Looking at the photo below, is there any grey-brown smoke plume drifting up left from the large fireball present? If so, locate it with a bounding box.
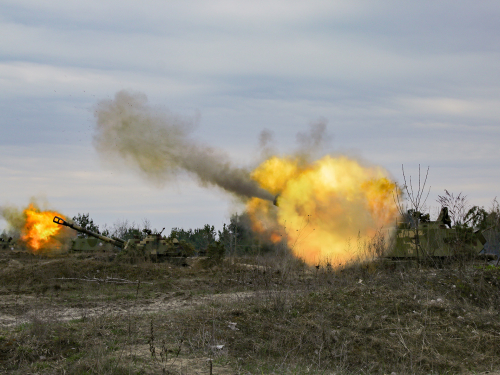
[94,91,274,201]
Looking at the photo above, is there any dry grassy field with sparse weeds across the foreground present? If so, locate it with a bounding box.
[0,252,500,374]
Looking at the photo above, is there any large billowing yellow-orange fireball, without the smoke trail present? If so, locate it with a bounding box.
[247,156,398,266]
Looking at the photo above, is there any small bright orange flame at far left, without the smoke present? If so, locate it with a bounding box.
[21,203,64,251]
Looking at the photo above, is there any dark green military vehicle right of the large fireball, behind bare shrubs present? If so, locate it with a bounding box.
[386,207,486,259]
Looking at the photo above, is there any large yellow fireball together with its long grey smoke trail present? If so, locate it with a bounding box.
[94,91,397,265]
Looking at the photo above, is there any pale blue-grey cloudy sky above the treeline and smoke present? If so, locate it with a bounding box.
[0,0,500,231]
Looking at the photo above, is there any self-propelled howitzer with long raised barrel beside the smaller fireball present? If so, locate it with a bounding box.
[53,216,193,264]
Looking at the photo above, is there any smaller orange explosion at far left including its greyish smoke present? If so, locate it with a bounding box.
[1,203,69,253]
